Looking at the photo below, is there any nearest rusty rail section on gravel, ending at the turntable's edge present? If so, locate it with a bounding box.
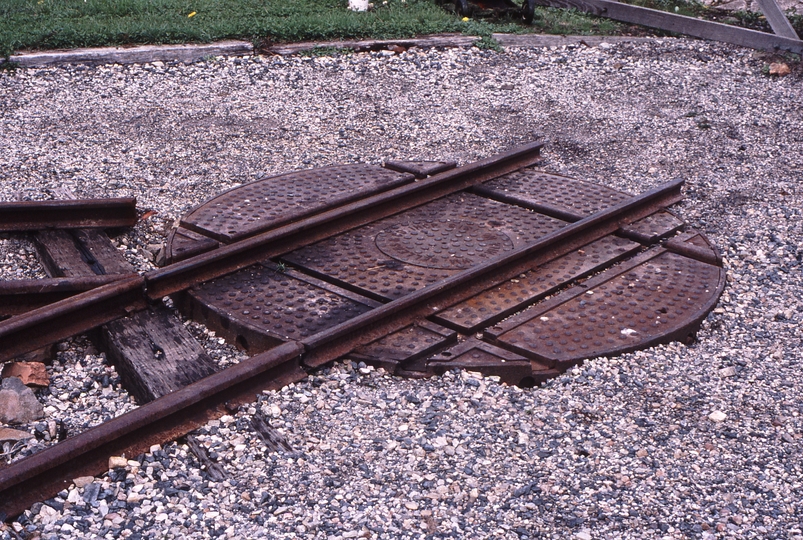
[0,342,306,516]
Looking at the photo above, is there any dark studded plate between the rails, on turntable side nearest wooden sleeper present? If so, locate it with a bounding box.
[182,265,376,352]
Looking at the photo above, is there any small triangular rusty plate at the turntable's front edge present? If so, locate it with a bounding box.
[426,338,560,387]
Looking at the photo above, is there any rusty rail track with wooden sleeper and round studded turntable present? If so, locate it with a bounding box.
[0,143,725,517]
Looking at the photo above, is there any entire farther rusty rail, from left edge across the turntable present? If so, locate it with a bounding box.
[0,141,544,361]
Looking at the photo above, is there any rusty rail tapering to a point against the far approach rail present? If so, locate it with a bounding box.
[0,274,136,317]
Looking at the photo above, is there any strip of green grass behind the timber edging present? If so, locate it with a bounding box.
[0,0,623,56]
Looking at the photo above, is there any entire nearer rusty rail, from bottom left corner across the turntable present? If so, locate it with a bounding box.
[0,177,682,515]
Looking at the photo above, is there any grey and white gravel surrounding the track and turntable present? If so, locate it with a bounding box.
[0,39,803,539]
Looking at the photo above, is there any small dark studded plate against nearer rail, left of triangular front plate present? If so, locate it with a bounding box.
[349,321,457,373]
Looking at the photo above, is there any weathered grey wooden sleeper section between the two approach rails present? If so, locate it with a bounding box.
[102,306,217,403]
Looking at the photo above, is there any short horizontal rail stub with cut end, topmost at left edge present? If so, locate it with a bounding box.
[0,197,137,232]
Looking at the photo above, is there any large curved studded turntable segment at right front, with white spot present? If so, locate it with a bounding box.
[486,248,725,368]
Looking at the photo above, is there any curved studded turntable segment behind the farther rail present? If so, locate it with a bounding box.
[181,164,414,243]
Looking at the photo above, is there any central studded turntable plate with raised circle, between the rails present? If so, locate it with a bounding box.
[283,193,566,300]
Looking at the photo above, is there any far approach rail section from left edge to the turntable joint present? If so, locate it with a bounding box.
[0,276,147,361]
